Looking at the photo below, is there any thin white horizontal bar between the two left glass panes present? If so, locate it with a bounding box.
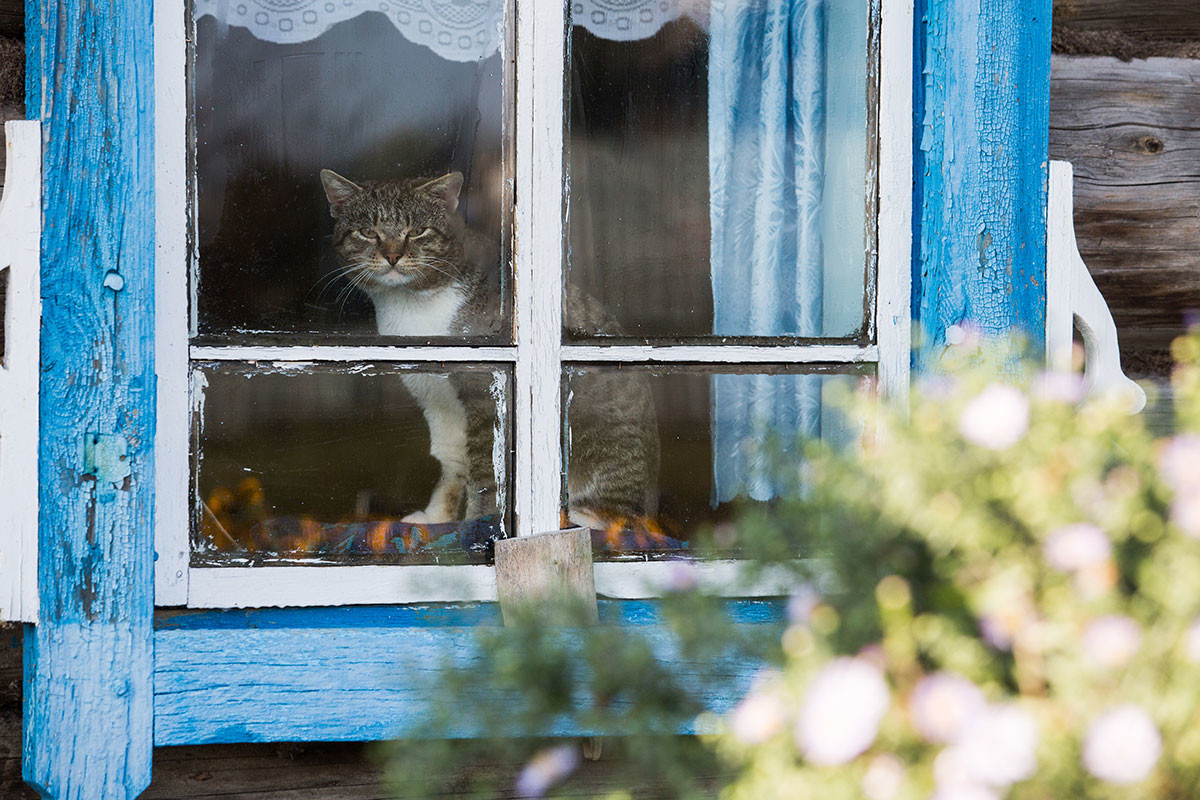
[191,345,517,363]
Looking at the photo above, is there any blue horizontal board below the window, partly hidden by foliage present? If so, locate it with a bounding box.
[155,601,784,745]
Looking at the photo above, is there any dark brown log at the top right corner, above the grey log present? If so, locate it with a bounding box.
[1054,0,1200,40]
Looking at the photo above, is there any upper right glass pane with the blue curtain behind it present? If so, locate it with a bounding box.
[564,0,875,339]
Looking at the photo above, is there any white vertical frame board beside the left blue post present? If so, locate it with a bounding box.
[154,0,191,606]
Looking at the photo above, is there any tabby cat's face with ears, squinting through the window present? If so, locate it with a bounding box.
[320,169,466,293]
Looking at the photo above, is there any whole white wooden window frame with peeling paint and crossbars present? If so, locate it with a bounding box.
[154,0,913,608]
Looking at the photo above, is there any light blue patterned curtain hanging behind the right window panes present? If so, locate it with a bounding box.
[708,0,827,503]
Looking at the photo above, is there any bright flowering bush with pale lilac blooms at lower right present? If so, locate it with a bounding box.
[709,328,1200,800]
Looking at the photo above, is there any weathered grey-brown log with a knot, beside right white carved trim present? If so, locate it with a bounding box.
[1050,55,1200,371]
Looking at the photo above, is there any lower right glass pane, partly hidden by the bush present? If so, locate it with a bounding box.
[564,366,864,554]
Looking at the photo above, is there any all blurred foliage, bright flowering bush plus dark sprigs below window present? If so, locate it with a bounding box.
[381,331,1200,800]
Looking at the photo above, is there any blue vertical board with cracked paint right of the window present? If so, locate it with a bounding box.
[913,0,1051,367]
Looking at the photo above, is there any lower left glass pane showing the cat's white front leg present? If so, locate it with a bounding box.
[192,363,511,564]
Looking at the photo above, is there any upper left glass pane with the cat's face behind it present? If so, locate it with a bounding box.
[191,6,511,342]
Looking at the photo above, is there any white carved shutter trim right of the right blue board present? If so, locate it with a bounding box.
[1046,161,1146,414]
